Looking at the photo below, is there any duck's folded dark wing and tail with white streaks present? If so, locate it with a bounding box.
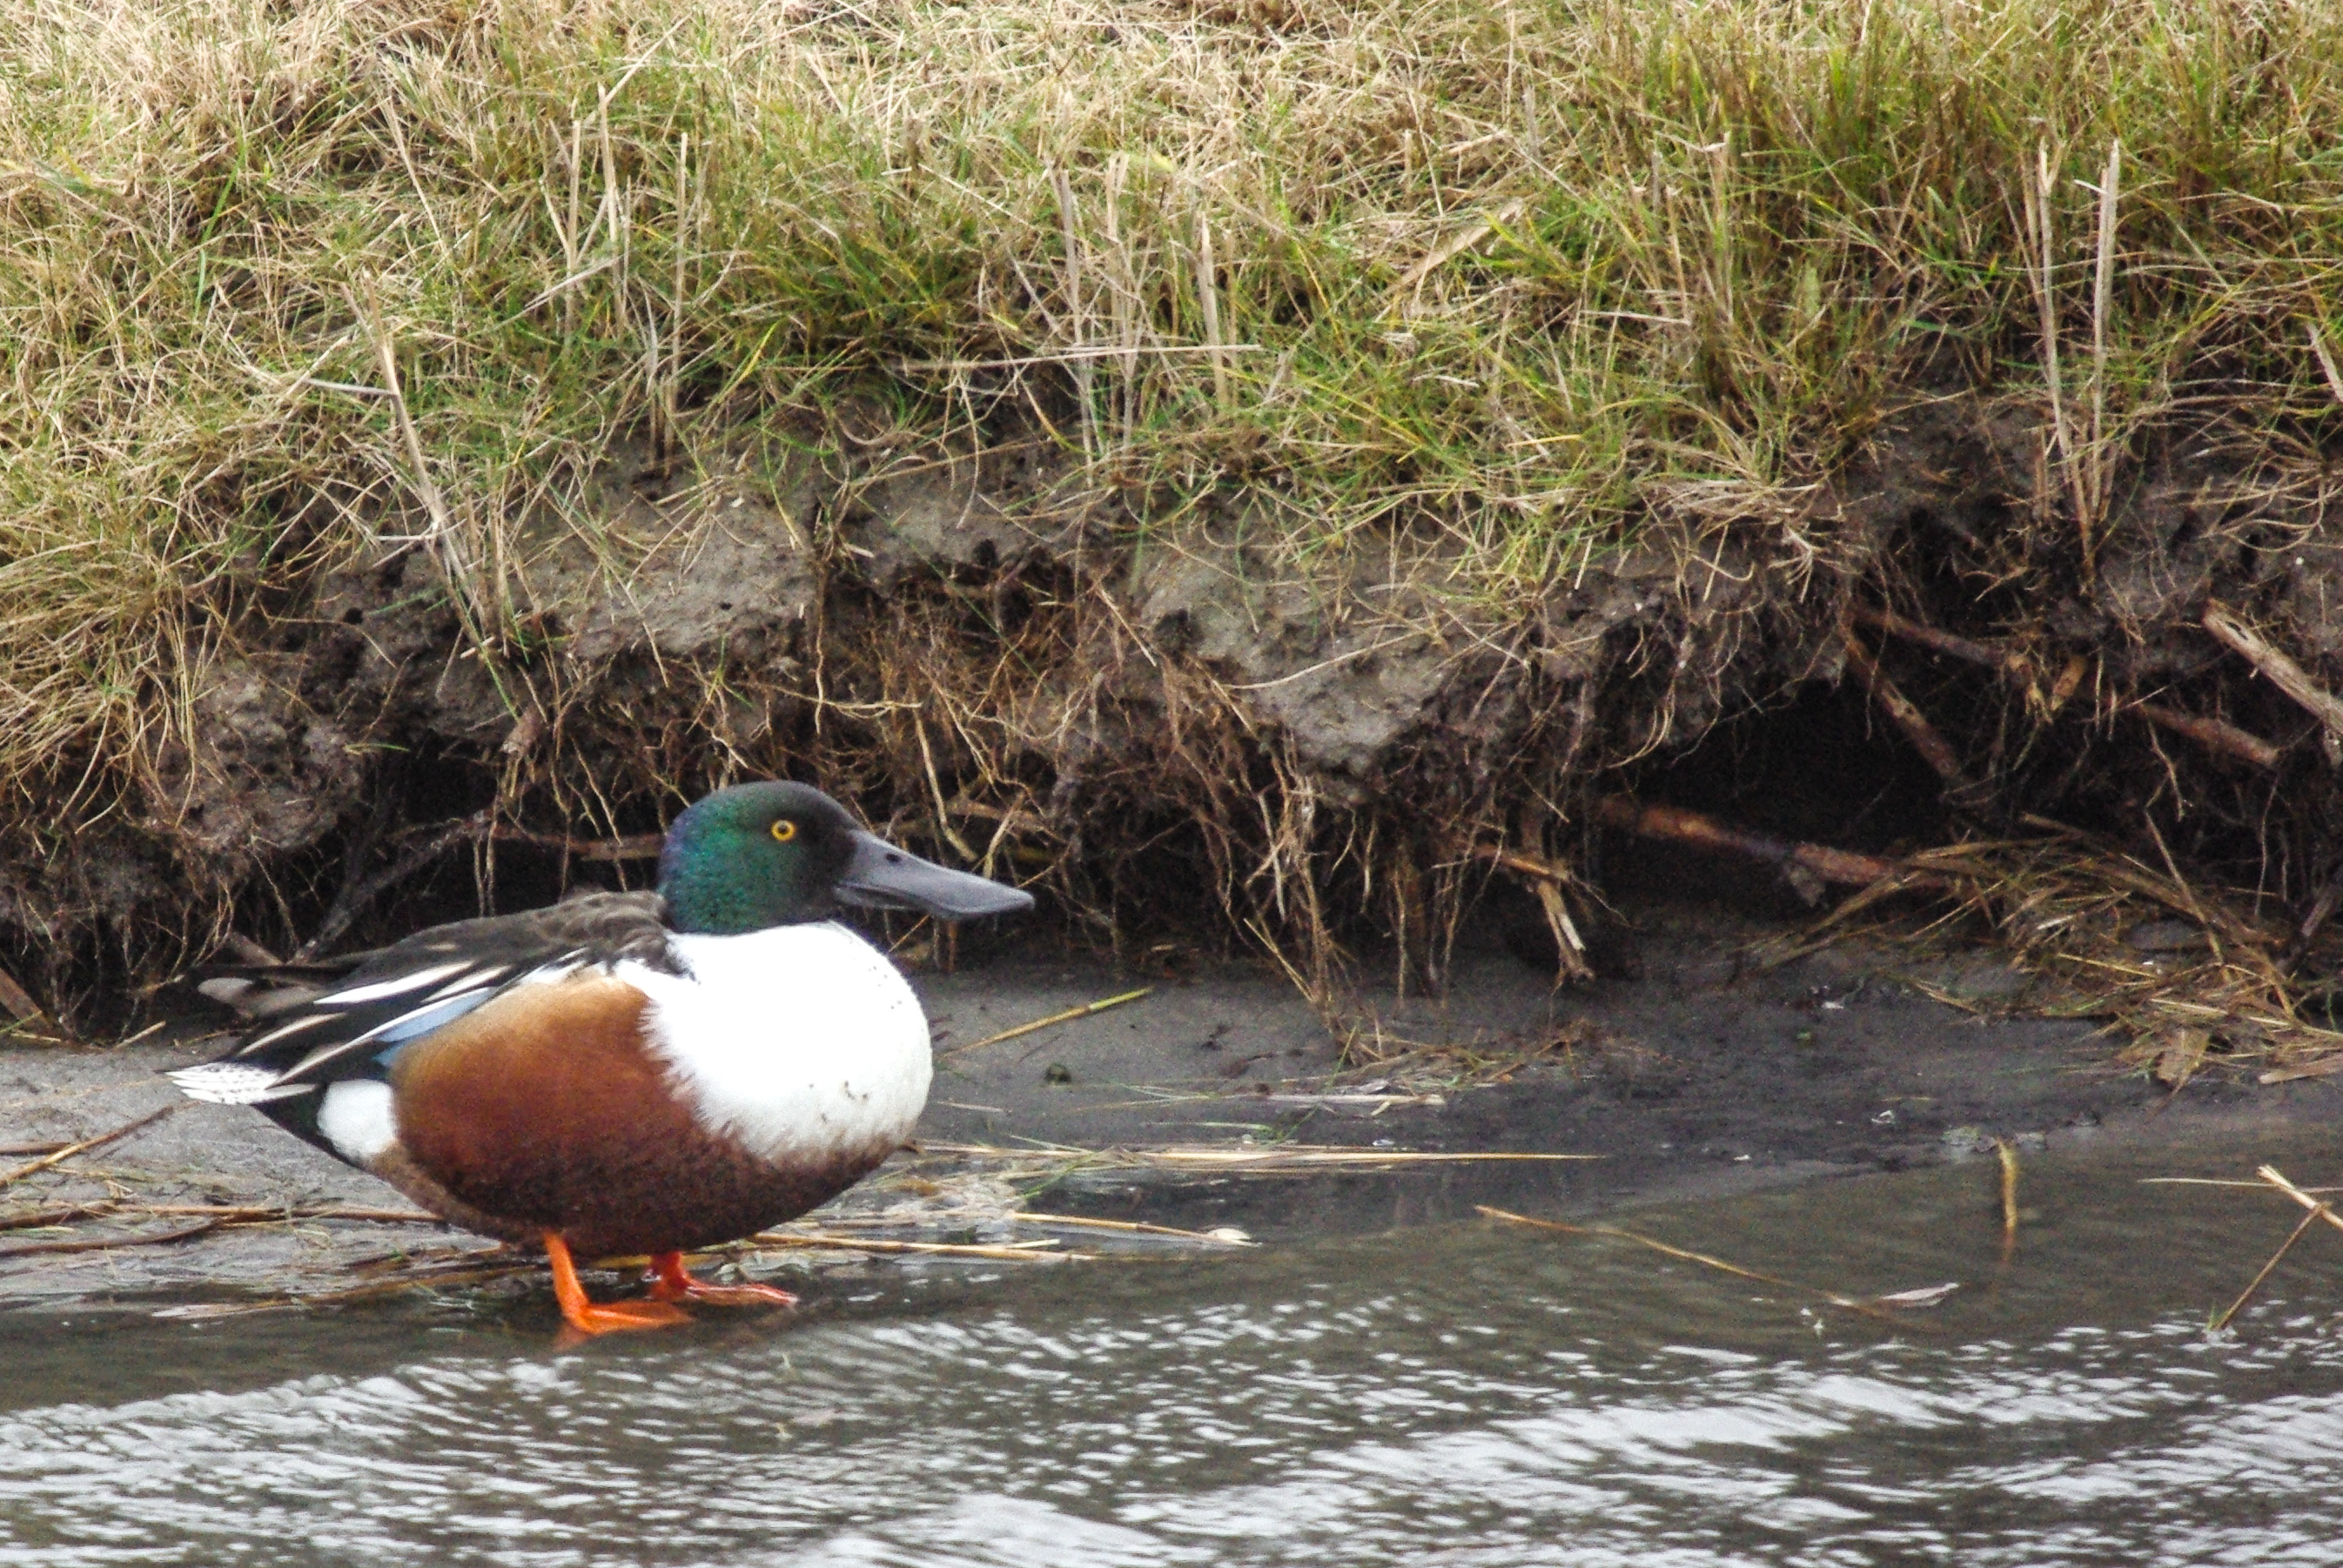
[169,893,668,1104]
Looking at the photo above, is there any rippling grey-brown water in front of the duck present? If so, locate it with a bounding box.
[0,1151,2343,1568]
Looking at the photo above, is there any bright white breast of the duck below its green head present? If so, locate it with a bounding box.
[616,921,935,1163]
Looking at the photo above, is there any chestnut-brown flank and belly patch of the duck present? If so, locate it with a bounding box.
[375,973,893,1256]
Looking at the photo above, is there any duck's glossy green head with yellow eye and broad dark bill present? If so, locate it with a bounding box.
[658,781,1033,935]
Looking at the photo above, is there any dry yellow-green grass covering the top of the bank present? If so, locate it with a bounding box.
[0,0,2343,979]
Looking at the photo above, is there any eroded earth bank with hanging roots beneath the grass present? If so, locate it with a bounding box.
[0,382,2343,1101]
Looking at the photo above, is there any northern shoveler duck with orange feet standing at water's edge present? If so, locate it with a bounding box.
[171,783,1033,1334]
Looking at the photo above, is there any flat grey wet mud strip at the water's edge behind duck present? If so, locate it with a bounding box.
[0,905,2336,1312]
